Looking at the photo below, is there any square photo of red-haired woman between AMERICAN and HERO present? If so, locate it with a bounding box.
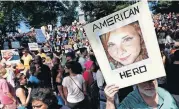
[100,21,148,69]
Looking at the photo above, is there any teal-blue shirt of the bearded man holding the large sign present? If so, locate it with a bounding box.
[117,87,179,109]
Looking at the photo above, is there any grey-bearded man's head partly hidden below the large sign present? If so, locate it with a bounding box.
[137,79,158,97]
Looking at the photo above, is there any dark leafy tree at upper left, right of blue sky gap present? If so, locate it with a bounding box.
[18,1,65,28]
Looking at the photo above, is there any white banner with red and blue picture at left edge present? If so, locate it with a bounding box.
[1,49,20,65]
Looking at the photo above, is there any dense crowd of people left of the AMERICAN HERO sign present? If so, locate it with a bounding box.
[0,23,105,109]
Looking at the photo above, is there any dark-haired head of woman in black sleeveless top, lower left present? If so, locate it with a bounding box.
[15,73,27,86]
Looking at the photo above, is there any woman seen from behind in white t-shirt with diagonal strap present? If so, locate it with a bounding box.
[62,61,87,109]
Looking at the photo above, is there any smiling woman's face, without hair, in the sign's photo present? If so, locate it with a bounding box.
[107,25,141,65]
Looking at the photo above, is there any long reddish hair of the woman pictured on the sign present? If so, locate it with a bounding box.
[101,21,148,68]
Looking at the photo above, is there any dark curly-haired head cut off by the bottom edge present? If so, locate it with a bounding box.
[31,88,59,109]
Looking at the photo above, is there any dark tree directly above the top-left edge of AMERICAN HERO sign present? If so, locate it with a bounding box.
[81,1,135,22]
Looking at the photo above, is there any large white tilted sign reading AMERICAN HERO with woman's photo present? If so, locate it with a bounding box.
[84,1,166,88]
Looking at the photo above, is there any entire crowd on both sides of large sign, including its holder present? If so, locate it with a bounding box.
[0,13,179,109]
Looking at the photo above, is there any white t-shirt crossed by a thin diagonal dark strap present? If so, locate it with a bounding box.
[62,74,85,103]
